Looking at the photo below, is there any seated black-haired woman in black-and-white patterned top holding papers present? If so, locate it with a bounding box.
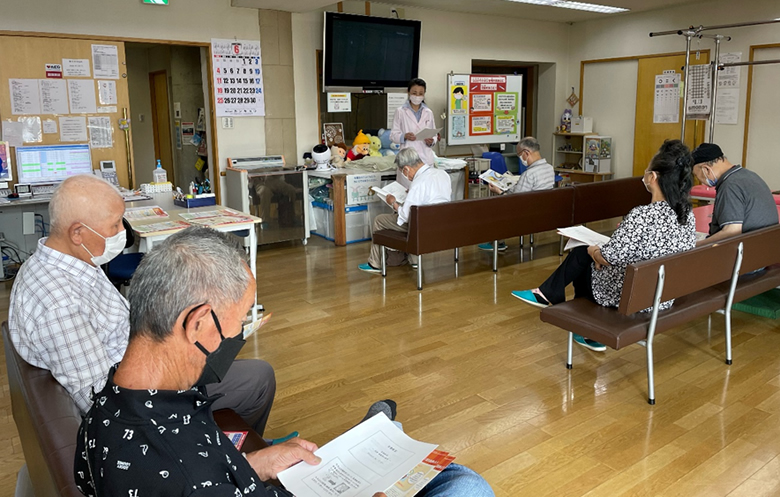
[512,140,696,350]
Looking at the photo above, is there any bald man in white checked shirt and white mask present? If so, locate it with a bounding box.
[8,175,276,434]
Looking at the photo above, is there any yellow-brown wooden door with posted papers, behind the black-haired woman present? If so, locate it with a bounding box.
[634,51,709,176]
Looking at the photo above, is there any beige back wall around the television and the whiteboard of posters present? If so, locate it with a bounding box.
[293,1,571,161]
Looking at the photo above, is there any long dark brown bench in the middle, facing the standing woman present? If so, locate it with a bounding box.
[373,178,650,290]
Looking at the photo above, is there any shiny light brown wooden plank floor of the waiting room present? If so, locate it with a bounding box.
[0,233,780,497]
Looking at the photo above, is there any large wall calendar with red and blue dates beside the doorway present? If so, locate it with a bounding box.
[211,39,265,117]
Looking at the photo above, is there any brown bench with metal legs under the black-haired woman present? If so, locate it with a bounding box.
[540,225,780,404]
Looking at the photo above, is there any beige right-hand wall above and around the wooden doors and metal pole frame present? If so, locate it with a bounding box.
[569,0,780,184]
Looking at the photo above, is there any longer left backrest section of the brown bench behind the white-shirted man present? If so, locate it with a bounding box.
[407,188,574,254]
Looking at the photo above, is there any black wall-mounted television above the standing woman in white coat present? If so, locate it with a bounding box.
[323,12,421,88]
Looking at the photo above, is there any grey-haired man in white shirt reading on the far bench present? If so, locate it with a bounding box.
[358,148,452,273]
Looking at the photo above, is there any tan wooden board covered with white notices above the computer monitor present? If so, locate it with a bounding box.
[0,35,132,188]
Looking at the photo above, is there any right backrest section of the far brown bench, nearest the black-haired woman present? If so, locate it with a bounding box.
[572,178,650,225]
